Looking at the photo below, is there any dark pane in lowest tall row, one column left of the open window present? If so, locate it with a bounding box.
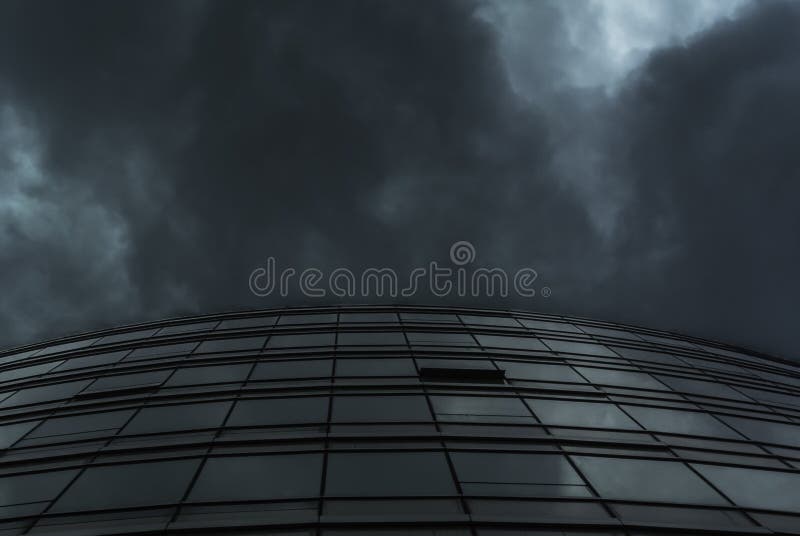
[325,451,456,497]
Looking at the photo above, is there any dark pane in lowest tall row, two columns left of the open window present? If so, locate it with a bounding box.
[189,453,322,501]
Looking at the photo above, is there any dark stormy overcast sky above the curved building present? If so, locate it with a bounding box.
[0,0,800,357]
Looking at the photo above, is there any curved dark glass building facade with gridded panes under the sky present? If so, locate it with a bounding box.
[0,306,800,536]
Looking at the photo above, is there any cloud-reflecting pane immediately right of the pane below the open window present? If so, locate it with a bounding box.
[526,398,640,430]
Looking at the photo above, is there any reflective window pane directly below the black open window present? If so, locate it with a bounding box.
[431,395,535,424]
